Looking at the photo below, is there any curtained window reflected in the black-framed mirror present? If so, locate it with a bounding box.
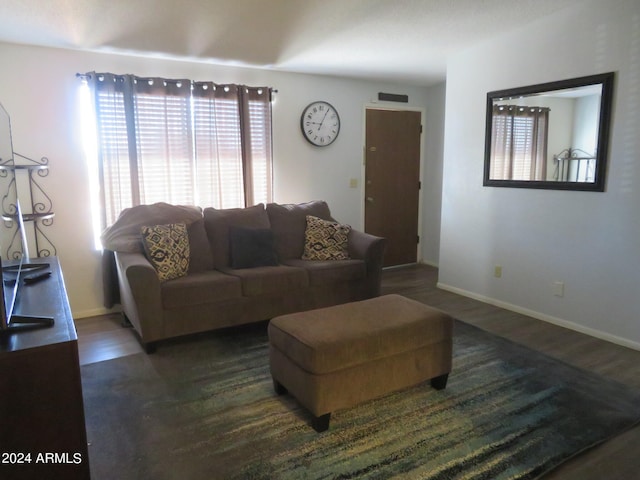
[490,105,549,180]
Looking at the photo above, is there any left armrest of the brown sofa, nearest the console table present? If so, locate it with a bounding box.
[115,252,164,345]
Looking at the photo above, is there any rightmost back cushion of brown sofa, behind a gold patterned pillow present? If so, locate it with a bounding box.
[267,200,334,261]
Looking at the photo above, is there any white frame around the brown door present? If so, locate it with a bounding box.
[360,102,427,268]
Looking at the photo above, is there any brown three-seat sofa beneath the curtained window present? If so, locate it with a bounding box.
[102,201,385,352]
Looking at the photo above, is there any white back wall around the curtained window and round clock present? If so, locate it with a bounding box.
[0,44,439,318]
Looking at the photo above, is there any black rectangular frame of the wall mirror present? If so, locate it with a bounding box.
[483,72,615,192]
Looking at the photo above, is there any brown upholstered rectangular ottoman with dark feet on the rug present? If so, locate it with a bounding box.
[269,295,453,432]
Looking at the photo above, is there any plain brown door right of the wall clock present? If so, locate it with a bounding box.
[365,109,422,266]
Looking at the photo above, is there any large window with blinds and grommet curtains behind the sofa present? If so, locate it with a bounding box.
[83,73,272,228]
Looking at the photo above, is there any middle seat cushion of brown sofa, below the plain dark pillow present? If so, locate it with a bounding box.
[223,265,309,297]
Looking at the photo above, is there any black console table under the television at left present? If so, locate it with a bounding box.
[0,257,90,480]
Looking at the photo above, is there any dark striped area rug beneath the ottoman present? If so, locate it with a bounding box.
[82,322,640,480]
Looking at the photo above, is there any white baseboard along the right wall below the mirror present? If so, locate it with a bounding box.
[436,282,640,351]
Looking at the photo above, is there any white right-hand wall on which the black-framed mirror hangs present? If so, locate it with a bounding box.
[439,0,640,349]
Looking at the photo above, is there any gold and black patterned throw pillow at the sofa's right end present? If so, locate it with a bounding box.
[302,215,351,260]
